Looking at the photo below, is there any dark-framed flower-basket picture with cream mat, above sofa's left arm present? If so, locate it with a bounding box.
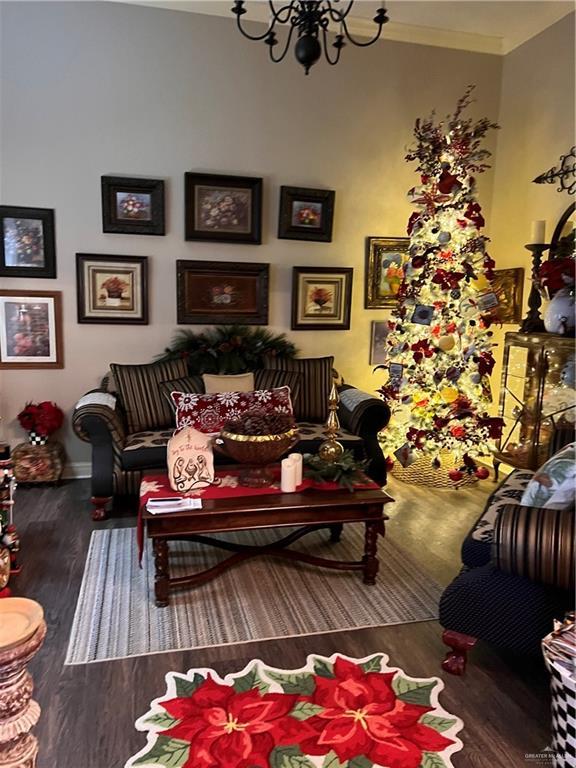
[76,253,148,325]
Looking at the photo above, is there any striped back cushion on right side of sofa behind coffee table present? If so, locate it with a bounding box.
[264,357,334,422]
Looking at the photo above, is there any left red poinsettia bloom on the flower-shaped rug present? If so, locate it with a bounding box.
[161,678,307,768]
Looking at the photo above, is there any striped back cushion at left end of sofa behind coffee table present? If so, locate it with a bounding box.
[110,360,187,433]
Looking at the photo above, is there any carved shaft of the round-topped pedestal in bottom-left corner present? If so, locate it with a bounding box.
[0,598,46,768]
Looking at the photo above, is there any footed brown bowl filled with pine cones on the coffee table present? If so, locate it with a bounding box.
[215,411,300,488]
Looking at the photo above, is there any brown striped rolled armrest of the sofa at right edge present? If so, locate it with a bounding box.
[492,504,574,590]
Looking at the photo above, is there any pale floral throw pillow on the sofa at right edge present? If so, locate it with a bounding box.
[520,443,576,509]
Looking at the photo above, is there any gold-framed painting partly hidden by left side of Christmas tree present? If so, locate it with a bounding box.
[364,237,410,309]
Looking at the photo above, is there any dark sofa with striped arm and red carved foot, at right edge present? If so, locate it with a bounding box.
[439,462,574,674]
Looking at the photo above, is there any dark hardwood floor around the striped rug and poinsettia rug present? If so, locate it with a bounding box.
[11,481,549,768]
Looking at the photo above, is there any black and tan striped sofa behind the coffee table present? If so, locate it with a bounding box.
[72,357,390,520]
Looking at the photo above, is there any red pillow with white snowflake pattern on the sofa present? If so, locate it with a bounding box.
[171,387,293,434]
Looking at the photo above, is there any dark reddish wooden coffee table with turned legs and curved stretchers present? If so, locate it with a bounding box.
[141,480,393,606]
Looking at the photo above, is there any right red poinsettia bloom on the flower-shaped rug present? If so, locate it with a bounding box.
[299,658,454,768]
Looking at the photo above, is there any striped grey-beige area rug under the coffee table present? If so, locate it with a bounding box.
[65,525,441,664]
